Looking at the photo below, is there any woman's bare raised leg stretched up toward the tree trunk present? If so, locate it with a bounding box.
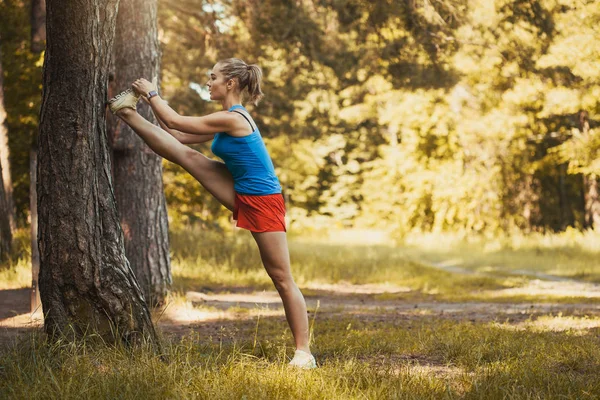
[117,108,235,210]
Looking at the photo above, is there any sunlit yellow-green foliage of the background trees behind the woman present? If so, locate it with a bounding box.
[0,0,600,237]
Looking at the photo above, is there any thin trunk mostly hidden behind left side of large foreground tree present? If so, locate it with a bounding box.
[29,0,46,313]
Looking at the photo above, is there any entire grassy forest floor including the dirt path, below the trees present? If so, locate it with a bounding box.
[0,236,600,399]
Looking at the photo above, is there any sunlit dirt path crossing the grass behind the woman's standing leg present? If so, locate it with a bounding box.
[0,281,600,345]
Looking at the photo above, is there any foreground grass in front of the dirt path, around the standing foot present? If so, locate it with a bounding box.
[0,316,600,399]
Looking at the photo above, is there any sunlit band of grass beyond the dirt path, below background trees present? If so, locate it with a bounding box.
[0,229,600,302]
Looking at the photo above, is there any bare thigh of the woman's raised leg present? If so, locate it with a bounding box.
[176,146,235,211]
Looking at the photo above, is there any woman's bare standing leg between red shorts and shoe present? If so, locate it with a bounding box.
[252,232,310,354]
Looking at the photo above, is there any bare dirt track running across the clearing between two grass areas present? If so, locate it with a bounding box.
[0,276,600,362]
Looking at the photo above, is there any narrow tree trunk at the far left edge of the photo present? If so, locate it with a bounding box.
[0,41,17,234]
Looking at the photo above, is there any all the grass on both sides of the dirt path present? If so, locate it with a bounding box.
[0,230,600,399]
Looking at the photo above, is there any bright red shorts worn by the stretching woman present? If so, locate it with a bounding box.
[233,193,286,232]
